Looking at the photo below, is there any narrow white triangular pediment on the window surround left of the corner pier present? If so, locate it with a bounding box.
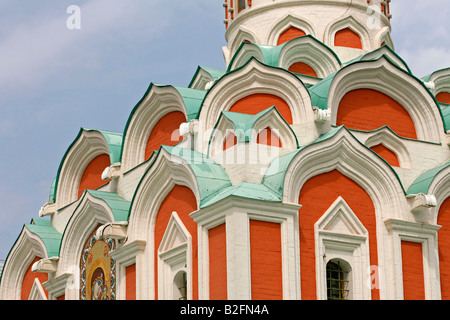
[158,211,191,253]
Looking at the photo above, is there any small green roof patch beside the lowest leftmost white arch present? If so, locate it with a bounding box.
[25,219,62,258]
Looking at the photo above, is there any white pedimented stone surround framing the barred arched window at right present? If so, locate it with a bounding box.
[314,197,371,300]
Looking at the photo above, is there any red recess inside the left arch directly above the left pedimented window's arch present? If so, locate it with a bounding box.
[145,111,186,159]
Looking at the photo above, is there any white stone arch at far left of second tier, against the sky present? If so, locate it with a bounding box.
[56,129,109,208]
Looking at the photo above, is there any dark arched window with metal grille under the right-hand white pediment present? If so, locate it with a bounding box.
[327,260,350,300]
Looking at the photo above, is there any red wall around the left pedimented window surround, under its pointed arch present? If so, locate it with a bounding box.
[155,185,198,300]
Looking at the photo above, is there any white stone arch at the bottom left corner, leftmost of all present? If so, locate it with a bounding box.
[0,226,49,300]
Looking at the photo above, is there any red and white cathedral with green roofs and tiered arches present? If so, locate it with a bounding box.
[0,0,450,300]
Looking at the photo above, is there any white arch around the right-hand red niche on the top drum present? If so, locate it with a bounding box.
[323,16,372,51]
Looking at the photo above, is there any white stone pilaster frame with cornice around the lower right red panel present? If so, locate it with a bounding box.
[385,219,441,300]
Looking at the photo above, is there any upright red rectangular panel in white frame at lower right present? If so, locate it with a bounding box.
[402,241,425,300]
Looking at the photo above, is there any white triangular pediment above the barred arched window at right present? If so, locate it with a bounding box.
[316,197,368,236]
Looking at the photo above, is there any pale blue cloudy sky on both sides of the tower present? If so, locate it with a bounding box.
[0,0,450,259]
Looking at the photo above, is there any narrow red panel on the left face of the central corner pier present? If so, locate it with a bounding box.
[208,224,227,300]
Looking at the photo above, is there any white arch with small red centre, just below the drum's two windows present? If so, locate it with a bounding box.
[279,36,341,78]
